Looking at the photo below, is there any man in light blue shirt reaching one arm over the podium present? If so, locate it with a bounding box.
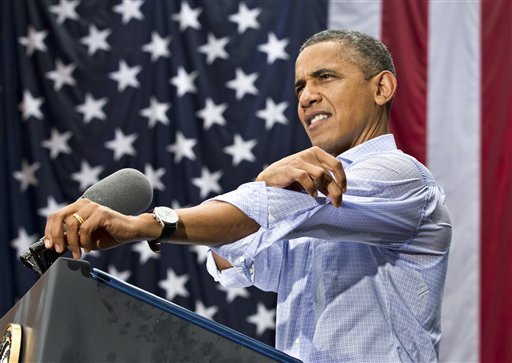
[45,31,451,362]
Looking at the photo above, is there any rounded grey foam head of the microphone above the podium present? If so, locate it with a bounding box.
[82,168,153,215]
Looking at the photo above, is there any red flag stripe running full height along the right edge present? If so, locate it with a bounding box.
[480,0,512,362]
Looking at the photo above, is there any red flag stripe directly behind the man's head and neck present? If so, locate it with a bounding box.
[381,0,428,163]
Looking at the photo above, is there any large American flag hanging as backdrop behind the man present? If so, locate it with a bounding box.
[0,0,512,362]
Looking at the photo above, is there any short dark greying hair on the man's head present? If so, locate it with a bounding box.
[299,29,396,79]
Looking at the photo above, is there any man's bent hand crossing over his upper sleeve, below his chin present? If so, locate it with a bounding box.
[256,146,347,207]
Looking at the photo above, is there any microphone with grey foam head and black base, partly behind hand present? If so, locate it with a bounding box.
[20,168,153,275]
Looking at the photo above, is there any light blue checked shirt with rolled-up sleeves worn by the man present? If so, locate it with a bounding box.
[207,134,451,362]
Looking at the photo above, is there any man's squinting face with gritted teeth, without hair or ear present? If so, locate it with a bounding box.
[295,41,378,155]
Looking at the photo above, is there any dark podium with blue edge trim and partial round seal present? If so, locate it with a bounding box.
[0,258,300,363]
